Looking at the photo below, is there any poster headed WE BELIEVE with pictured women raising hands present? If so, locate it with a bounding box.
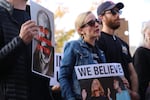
[75,63,131,100]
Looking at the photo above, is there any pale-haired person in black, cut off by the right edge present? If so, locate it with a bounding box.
[134,21,150,100]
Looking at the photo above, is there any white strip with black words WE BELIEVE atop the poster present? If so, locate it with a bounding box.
[75,63,124,80]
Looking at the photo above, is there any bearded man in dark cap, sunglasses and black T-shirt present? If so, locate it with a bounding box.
[96,1,139,100]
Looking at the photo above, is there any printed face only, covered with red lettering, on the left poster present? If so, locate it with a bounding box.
[38,10,51,64]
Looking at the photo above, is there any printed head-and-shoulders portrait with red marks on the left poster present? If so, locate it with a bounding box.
[33,10,54,76]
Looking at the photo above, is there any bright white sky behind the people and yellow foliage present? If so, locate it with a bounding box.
[30,0,150,47]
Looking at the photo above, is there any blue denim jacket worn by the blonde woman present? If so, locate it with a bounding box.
[59,39,106,100]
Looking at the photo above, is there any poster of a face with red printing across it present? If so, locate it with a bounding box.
[30,0,54,78]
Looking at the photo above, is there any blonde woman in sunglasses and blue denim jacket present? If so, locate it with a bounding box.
[58,11,106,100]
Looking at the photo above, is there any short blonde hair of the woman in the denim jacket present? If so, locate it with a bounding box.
[75,11,92,36]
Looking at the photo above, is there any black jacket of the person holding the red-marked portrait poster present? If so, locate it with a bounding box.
[0,0,51,100]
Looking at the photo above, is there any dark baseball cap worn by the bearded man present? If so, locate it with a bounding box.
[97,1,124,15]
